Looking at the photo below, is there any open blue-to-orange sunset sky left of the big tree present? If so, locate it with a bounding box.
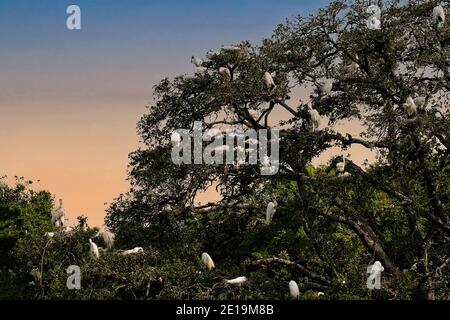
[0,0,346,226]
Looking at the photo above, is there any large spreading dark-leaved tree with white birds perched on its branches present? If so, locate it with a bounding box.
[107,1,450,299]
